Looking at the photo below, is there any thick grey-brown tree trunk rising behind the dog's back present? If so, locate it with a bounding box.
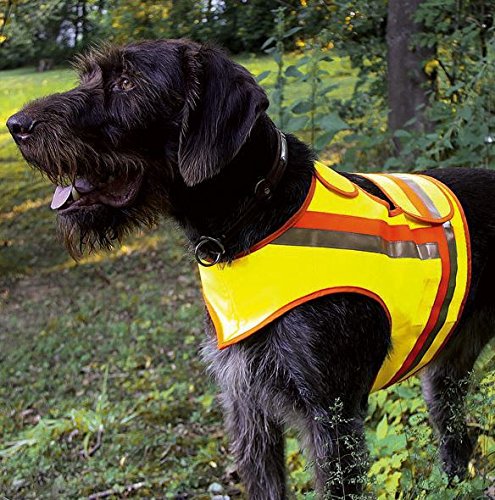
[387,0,435,153]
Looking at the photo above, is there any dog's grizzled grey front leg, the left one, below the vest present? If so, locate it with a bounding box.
[202,328,287,500]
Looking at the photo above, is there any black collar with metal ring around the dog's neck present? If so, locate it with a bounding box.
[194,129,289,267]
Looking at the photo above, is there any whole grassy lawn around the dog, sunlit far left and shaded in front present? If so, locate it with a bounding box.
[0,57,495,499]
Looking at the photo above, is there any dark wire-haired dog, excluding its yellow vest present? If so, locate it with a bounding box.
[7,40,495,500]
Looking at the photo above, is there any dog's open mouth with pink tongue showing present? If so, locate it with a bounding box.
[50,173,143,214]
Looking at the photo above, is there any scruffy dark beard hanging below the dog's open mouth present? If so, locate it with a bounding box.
[58,205,156,260]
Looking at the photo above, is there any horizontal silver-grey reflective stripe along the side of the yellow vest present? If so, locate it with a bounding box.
[271,228,440,260]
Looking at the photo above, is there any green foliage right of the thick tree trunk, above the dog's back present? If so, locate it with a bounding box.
[396,0,495,168]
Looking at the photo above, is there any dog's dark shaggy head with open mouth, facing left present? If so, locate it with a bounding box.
[7,40,268,256]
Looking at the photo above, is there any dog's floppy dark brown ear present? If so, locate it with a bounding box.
[178,47,268,186]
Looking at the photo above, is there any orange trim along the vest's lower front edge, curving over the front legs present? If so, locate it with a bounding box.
[215,286,392,349]
